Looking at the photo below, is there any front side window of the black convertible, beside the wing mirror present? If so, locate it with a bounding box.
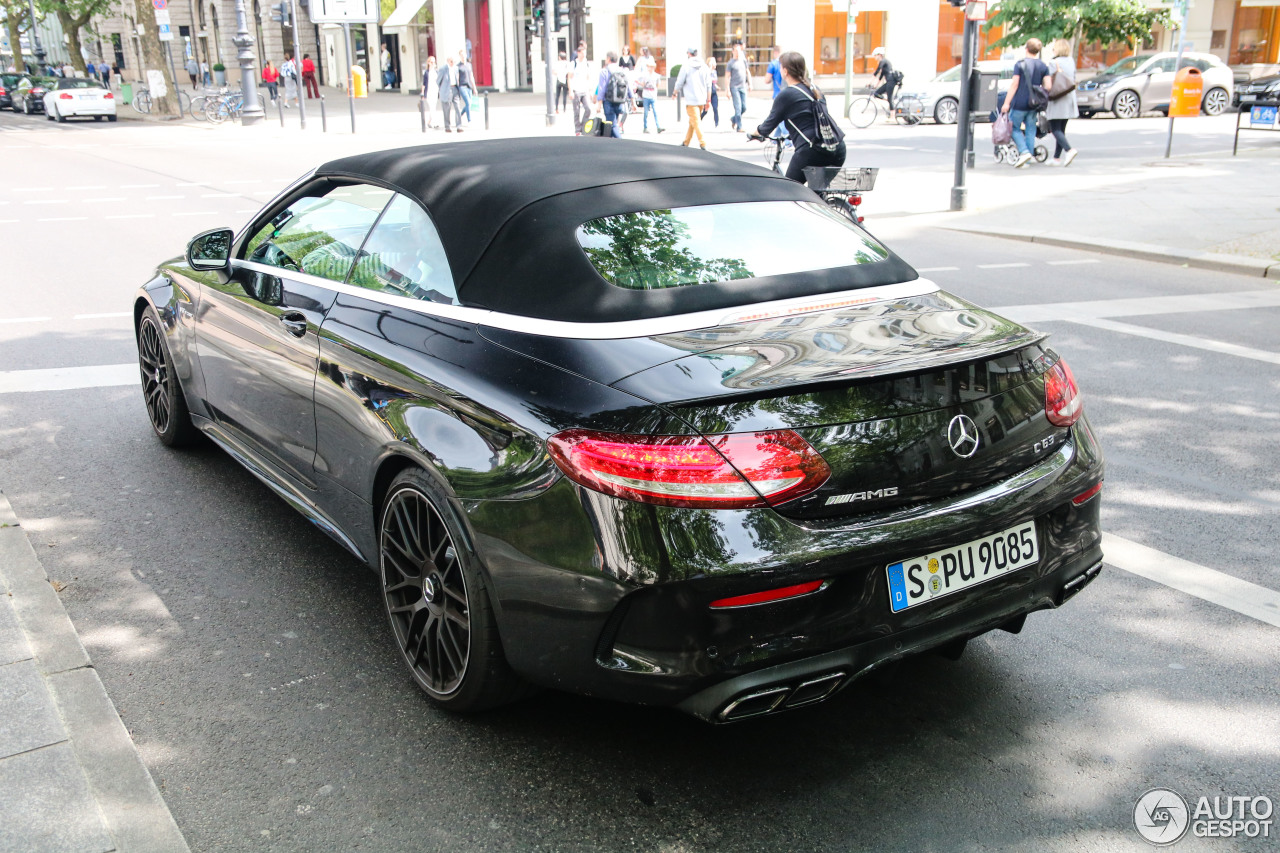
[246,183,393,282]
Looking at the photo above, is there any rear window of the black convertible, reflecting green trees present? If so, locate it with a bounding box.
[577,201,888,291]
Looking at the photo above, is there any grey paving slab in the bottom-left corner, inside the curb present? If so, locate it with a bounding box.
[0,743,115,853]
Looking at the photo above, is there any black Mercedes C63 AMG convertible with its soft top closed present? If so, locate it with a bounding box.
[134,140,1102,722]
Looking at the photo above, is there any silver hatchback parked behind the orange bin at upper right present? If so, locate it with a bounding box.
[1076,53,1234,118]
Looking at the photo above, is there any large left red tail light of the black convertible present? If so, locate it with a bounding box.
[547,429,831,510]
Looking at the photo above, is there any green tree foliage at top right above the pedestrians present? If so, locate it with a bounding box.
[984,0,1172,47]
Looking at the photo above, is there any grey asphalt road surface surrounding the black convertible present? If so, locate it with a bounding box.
[0,114,1280,852]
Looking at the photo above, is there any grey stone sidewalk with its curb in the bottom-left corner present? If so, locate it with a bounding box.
[0,493,187,853]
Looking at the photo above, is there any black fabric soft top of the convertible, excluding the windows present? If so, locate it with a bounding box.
[316,137,916,323]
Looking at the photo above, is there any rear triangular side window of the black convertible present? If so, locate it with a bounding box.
[347,196,458,305]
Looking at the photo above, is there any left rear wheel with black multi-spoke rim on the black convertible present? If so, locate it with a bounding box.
[378,467,529,713]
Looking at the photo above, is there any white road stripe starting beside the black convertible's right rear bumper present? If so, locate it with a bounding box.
[1102,533,1280,628]
